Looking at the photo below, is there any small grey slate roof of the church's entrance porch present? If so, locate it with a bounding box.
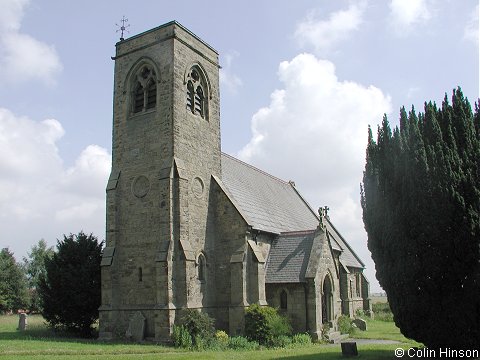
[265,230,314,283]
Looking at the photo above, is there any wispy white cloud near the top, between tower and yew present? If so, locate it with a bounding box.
[295,2,365,54]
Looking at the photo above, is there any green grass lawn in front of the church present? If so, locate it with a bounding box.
[0,316,418,360]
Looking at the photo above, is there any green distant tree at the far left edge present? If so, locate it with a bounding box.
[0,248,29,312]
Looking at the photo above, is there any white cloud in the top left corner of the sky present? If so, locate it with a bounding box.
[0,0,62,84]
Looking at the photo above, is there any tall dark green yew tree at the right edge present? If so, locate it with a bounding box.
[361,88,480,348]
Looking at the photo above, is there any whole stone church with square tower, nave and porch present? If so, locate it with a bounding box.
[99,21,370,340]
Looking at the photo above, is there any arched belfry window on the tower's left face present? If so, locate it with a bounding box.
[132,65,157,114]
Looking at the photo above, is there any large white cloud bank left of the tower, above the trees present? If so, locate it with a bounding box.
[0,108,110,258]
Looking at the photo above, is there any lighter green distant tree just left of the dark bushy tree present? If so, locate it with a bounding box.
[23,239,54,312]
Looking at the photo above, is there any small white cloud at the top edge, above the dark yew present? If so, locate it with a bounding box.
[390,0,432,34]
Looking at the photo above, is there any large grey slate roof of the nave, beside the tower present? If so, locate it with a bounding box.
[222,154,318,234]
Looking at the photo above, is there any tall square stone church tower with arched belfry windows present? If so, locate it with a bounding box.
[100,22,221,339]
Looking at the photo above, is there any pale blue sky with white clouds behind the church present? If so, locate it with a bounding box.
[0,0,479,292]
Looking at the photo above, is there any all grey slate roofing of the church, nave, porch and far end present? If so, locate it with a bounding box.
[217,153,364,276]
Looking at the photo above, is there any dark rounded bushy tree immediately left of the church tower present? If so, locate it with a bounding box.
[38,232,103,336]
